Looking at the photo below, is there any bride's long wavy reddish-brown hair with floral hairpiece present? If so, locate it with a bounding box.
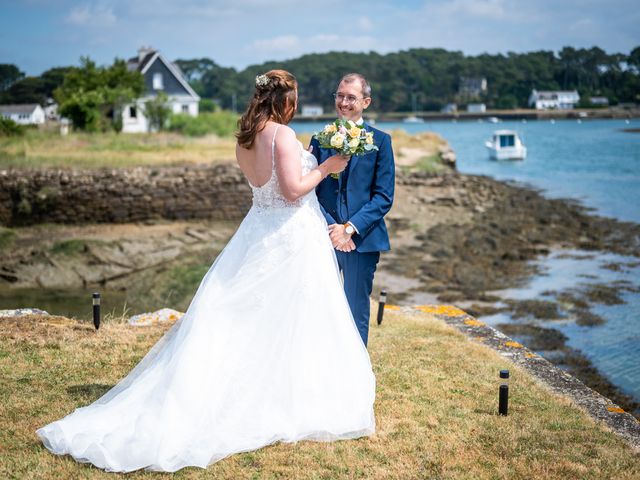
[236,70,298,148]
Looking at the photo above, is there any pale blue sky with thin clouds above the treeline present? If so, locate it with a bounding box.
[0,0,640,75]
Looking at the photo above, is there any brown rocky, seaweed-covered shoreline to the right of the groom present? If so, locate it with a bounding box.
[376,172,640,418]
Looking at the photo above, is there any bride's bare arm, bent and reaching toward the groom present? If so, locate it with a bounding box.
[275,127,348,202]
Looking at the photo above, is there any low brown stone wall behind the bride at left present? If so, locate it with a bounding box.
[0,164,251,227]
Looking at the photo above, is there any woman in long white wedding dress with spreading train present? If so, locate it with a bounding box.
[37,70,375,472]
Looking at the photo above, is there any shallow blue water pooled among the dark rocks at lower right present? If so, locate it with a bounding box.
[482,250,640,401]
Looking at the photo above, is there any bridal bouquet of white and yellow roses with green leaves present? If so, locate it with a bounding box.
[313,118,378,179]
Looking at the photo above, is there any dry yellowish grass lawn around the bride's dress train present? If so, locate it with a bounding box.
[0,311,640,479]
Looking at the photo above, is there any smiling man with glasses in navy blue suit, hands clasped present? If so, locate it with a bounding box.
[311,73,395,345]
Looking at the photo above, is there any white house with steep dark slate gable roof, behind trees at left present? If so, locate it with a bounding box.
[122,48,200,133]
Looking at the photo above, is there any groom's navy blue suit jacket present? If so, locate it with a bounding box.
[311,123,395,253]
